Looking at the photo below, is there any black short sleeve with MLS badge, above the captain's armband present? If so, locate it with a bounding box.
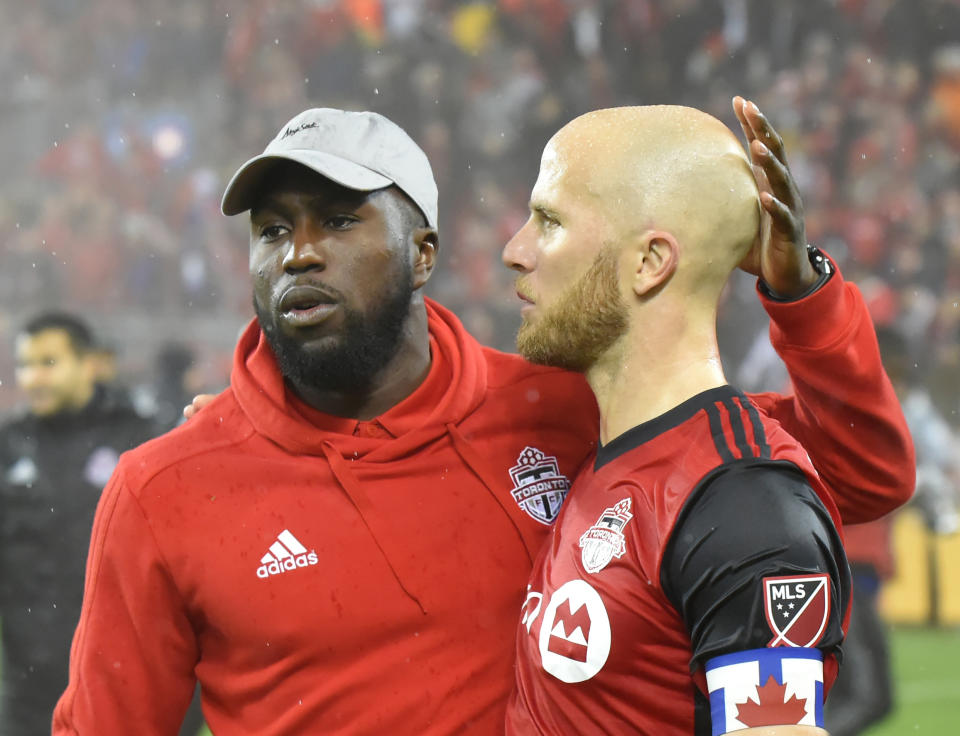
[660,460,850,671]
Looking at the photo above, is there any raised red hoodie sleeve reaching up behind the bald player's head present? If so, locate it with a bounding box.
[752,253,916,523]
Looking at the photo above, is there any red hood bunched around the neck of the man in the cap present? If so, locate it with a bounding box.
[230,299,487,462]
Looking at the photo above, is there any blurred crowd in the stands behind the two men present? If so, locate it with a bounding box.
[0,0,960,436]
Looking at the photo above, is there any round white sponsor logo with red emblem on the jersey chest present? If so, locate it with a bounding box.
[534,580,610,683]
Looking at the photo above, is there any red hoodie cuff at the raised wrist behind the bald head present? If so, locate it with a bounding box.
[757,255,850,349]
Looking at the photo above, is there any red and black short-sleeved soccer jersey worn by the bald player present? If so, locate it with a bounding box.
[507,387,849,736]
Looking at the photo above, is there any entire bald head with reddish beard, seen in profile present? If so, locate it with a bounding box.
[503,106,760,372]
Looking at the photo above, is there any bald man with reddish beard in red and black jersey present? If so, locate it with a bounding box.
[503,106,850,736]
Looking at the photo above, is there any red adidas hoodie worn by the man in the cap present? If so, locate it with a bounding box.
[54,276,912,736]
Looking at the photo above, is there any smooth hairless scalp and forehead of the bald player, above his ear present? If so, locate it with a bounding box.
[537,105,760,298]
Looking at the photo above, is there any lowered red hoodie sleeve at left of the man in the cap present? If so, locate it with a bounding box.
[53,466,197,736]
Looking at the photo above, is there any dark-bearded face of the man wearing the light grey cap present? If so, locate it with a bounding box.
[250,162,437,419]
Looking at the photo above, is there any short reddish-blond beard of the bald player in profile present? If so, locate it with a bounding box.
[517,246,629,373]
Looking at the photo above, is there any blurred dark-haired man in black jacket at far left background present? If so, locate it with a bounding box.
[0,313,199,736]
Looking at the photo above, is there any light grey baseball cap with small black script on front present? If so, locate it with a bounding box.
[220,107,437,228]
